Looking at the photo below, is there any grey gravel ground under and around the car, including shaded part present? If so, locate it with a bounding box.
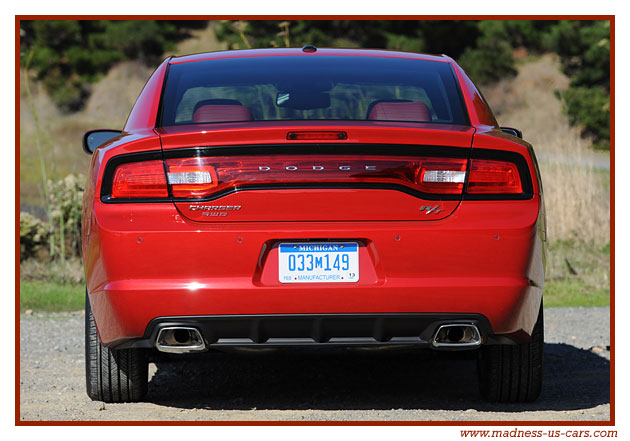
[20,308,610,421]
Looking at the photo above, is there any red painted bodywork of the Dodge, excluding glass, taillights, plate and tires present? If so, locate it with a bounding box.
[82,49,546,402]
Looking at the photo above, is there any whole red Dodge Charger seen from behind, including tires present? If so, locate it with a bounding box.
[82,46,546,402]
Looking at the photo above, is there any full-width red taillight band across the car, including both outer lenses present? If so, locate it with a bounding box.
[103,150,532,200]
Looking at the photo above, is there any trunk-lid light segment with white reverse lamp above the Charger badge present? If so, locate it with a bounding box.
[166,158,219,198]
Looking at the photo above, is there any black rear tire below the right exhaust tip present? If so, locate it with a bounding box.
[477,304,545,403]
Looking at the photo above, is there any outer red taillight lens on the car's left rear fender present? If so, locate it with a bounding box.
[111,161,168,198]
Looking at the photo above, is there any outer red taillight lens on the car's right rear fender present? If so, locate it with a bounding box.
[467,159,523,194]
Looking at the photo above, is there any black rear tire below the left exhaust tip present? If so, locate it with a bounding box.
[85,293,149,403]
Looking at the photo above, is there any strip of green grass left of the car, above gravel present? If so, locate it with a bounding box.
[20,280,85,312]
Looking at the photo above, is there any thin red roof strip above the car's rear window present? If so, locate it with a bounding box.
[169,48,453,64]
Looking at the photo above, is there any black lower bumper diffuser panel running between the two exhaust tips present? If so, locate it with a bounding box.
[117,313,496,349]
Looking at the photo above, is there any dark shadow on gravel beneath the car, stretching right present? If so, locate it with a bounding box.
[147,343,610,412]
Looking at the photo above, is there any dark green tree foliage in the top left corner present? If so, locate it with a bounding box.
[20,20,207,112]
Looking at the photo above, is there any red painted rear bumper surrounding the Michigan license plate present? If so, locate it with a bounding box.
[84,197,544,346]
